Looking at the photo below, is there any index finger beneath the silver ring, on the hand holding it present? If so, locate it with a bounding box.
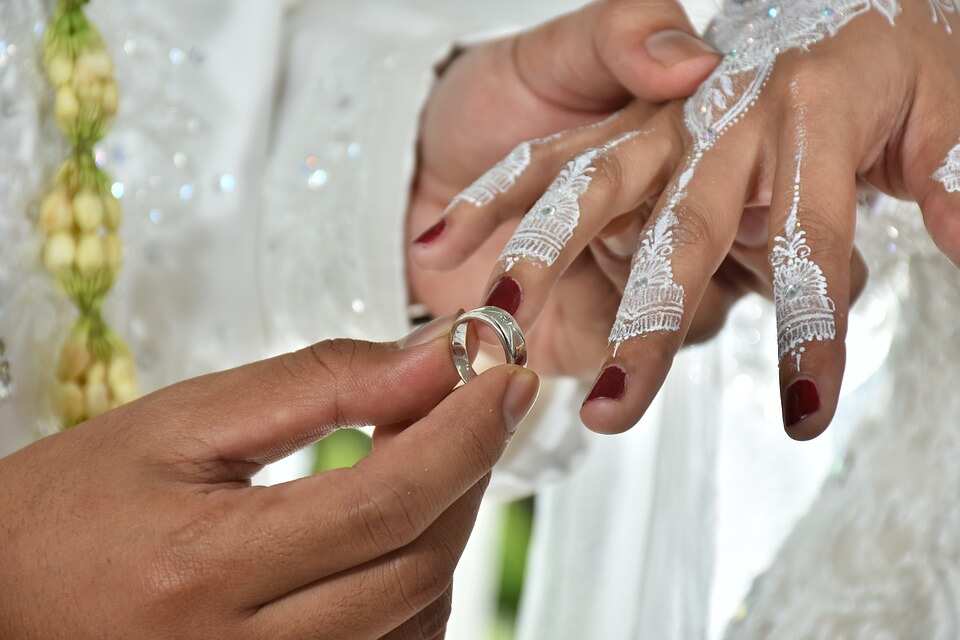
[232,365,539,598]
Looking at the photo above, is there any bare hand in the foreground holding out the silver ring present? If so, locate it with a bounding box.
[0,320,538,640]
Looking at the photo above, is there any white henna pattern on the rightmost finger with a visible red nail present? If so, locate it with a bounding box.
[770,108,837,371]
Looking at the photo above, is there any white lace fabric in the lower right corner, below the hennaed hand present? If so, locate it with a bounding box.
[726,246,960,640]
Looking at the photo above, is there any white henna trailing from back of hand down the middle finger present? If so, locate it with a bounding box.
[610,0,900,354]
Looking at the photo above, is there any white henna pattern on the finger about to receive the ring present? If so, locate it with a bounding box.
[500,131,640,271]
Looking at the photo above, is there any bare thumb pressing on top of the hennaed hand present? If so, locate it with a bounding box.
[515,0,720,111]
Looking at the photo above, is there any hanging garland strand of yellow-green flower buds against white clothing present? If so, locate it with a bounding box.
[39,0,139,428]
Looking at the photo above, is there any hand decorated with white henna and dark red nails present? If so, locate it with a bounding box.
[414,0,960,439]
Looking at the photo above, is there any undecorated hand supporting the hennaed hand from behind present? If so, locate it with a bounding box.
[407,0,866,380]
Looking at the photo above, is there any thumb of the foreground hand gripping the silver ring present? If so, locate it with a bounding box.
[143,316,468,464]
